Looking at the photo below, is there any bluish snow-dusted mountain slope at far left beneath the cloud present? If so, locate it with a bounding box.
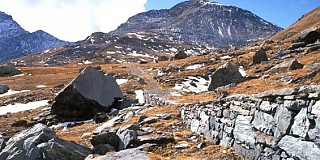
[0,12,70,62]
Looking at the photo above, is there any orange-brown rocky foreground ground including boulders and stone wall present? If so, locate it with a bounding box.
[0,1,320,160]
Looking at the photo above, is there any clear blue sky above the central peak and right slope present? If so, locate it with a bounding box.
[145,0,320,28]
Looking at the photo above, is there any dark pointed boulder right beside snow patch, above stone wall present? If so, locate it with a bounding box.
[208,62,244,91]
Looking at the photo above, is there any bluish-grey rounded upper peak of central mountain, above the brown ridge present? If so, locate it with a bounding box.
[109,0,282,48]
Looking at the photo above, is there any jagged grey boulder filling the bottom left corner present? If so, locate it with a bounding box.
[0,124,91,160]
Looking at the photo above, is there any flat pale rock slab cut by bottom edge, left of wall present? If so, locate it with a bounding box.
[85,148,150,160]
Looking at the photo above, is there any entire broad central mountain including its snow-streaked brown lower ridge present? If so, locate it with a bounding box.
[6,0,281,66]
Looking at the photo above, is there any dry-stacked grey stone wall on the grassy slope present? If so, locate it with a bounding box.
[181,85,320,160]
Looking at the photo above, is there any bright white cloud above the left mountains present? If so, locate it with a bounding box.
[0,0,147,41]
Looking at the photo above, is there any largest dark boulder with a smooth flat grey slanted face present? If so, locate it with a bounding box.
[51,67,123,120]
